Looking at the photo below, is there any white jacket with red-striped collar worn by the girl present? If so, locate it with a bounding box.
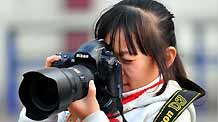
[19,78,196,122]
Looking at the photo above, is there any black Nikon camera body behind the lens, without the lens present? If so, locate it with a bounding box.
[52,40,122,113]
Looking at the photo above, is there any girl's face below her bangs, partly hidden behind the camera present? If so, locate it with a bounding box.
[105,29,159,92]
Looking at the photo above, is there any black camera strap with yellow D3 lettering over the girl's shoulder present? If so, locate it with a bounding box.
[153,90,202,122]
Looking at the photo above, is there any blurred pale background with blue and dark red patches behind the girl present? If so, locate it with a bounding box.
[0,0,218,122]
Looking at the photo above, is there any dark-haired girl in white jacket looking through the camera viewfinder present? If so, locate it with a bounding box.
[19,0,204,122]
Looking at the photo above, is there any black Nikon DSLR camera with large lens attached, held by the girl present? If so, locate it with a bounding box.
[19,39,122,121]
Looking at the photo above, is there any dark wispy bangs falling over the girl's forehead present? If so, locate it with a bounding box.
[95,5,159,55]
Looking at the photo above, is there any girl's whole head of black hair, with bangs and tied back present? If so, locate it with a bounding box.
[95,0,187,95]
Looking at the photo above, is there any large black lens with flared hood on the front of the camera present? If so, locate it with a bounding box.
[19,65,94,121]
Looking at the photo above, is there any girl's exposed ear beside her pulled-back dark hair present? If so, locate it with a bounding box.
[166,46,176,67]
